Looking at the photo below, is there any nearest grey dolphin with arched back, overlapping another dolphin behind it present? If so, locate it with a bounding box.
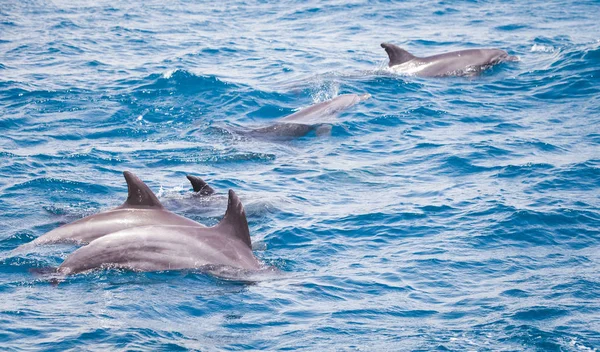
[58,190,264,275]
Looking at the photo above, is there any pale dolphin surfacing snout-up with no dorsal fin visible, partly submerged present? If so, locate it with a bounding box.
[242,94,371,139]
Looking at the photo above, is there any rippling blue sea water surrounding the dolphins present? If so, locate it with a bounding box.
[0,0,600,351]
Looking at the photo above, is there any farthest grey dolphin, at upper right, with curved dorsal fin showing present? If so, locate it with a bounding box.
[381,43,519,77]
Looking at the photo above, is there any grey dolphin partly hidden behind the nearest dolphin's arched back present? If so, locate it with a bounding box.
[15,171,205,252]
